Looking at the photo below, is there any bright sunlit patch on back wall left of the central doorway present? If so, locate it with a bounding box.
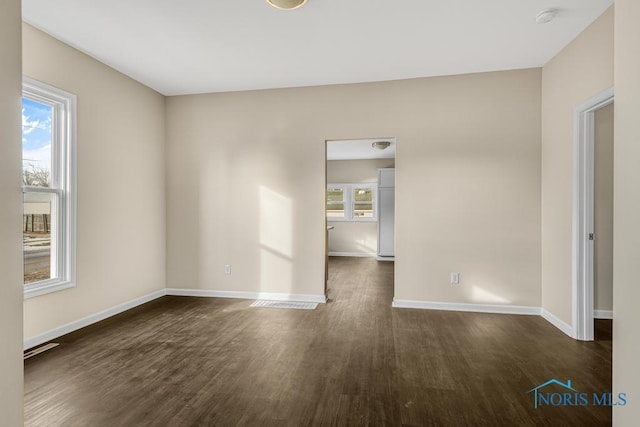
[259,185,293,293]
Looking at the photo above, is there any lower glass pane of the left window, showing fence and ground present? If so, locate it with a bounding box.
[22,192,56,284]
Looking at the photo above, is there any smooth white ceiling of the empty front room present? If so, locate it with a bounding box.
[22,0,613,95]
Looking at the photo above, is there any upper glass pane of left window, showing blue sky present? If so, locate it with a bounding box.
[22,98,53,187]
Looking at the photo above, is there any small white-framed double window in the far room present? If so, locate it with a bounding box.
[327,184,377,221]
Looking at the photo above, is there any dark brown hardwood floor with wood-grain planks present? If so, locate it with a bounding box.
[25,258,611,427]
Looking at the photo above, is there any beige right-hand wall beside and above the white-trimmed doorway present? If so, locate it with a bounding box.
[542,8,613,325]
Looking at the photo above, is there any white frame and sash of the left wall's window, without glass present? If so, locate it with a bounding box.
[22,77,76,299]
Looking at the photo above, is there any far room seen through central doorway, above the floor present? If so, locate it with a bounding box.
[325,137,396,300]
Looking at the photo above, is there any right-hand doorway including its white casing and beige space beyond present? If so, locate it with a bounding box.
[572,89,614,341]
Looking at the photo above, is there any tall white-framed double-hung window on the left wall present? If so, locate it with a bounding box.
[22,78,76,298]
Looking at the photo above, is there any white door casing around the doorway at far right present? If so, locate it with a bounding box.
[565,88,614,341]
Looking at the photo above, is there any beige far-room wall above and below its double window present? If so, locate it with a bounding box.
[327,159,395,255]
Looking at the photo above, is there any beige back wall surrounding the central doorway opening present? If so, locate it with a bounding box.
[167,69,541,306]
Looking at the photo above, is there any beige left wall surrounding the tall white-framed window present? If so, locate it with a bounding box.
[23,24,165,338]
